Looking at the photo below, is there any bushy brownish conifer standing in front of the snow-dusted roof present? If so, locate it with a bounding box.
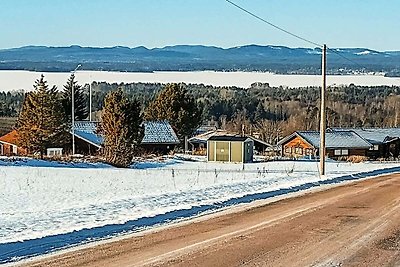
[99,89,144,167]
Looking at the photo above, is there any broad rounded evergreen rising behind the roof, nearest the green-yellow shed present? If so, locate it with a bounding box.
[145,83,202,140]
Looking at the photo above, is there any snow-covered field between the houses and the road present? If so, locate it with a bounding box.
[0,158,400,263]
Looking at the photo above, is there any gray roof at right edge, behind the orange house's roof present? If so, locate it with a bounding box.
[331,128,400,145]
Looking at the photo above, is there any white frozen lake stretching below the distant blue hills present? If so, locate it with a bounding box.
[0,70,400,91]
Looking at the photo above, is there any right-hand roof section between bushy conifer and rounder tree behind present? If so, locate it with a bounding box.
[142,121,179,145]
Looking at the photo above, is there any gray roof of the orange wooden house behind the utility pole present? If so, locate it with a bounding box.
[278,131,372,149]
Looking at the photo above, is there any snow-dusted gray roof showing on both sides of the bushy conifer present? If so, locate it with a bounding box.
[74,121,179,148]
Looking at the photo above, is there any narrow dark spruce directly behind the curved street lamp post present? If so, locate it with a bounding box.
[61,74,88,123]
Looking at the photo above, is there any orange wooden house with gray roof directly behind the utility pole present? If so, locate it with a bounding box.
[278,131,373,158]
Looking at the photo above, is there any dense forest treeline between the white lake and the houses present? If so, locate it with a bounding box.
[0,82,400,143]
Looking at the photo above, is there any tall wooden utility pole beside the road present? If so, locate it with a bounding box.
[319,44,326,175]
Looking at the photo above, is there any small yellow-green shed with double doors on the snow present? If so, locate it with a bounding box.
[207,135,254,163]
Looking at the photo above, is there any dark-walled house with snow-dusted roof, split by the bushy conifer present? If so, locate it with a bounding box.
[74,121,179,154]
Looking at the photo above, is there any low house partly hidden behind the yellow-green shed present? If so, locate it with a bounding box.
[188,130,273,155]
